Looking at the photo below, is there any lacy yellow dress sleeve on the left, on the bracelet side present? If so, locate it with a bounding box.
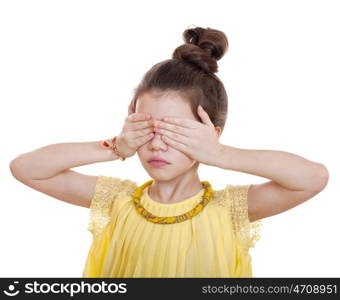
[87,175,122,235]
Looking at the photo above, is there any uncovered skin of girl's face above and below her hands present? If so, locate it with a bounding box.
[136,91,199,181]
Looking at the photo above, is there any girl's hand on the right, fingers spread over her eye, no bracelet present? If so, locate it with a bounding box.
[155,105,222,165]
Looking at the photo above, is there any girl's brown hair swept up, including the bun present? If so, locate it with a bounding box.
[129,27,228,131]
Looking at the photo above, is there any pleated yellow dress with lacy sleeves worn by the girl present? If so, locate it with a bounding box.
[82,175,262,278]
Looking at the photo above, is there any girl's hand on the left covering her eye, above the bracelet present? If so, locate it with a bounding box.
[116,113,154,158]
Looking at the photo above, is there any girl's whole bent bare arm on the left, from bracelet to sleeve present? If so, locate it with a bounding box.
[10,141,122,207]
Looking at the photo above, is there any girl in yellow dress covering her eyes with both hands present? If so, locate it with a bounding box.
[10,27,328,277]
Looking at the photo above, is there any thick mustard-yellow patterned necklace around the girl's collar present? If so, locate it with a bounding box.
[132,180,212,224]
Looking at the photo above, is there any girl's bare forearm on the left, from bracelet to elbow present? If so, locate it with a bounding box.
[10,141,118,179]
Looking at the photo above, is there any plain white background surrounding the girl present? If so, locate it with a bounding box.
[0,0,340,277]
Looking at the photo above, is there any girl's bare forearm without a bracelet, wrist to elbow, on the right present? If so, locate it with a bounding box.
[212,145,328,190]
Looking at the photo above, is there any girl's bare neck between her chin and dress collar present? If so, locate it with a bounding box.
[148,166,203,203]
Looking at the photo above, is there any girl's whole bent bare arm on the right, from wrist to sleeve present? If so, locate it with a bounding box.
[211,144,329,222]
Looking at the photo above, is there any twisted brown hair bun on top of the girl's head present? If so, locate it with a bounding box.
[172,27,228,73]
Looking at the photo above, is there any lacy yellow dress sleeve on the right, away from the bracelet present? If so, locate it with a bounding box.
[225,184,262,251]
